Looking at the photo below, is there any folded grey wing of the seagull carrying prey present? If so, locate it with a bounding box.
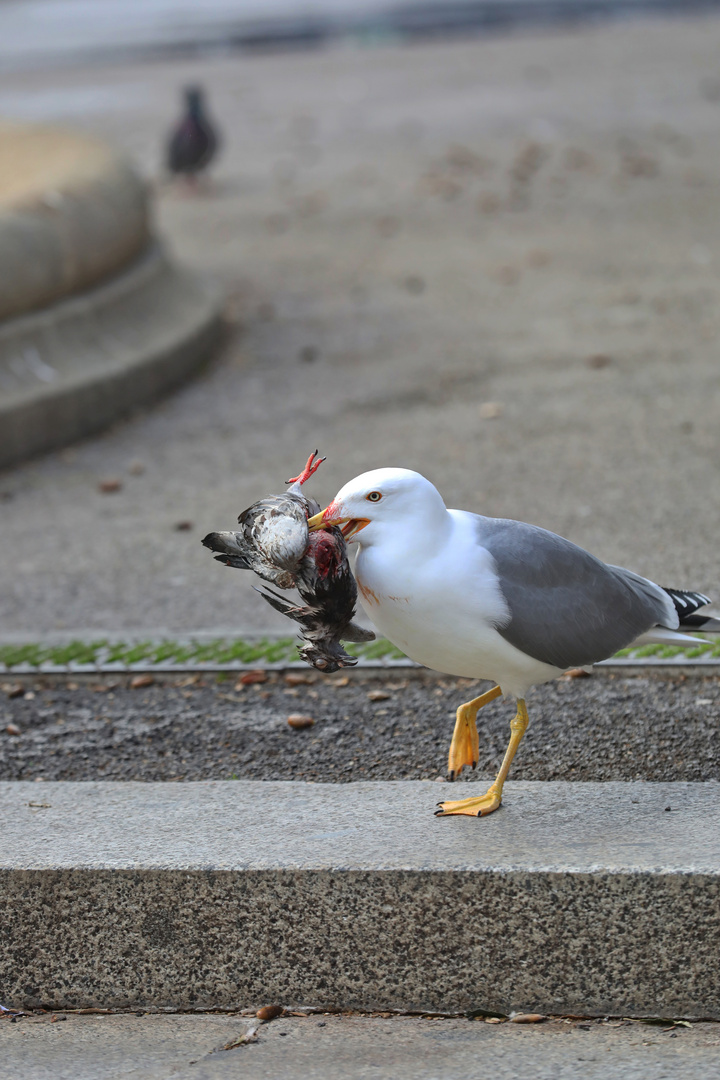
[476,517,678,669]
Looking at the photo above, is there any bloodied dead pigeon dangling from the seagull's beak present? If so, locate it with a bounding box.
[203,450,375,674]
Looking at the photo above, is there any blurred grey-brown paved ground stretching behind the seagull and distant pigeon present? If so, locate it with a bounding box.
[0,18,720,632]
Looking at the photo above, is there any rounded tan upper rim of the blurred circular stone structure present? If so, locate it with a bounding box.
[0,124,149,319]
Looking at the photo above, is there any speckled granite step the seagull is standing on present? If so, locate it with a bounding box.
[5,781,720,1018]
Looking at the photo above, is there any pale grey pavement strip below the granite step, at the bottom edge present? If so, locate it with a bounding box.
[5,1014,720,1080]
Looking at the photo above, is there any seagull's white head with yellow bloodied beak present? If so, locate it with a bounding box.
[308,469,447,546]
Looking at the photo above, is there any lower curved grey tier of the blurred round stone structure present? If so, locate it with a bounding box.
[0,247,219,468]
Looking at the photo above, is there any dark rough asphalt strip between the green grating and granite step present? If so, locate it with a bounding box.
[0,673,720,783]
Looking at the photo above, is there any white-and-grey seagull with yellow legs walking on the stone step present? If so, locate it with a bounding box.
[308,469,720,818]
